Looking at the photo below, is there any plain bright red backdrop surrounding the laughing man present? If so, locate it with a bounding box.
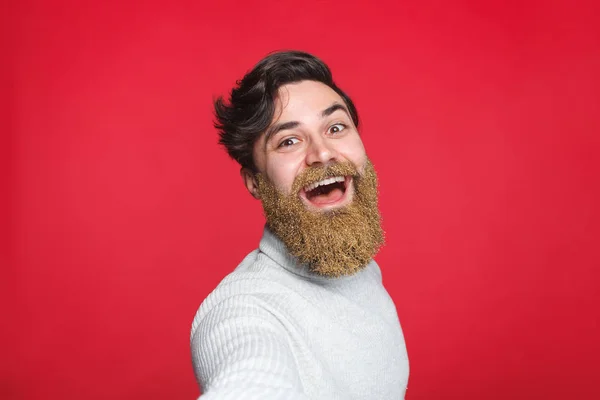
[0,0,600,400]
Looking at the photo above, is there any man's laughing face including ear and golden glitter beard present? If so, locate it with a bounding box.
[243,81,383,277]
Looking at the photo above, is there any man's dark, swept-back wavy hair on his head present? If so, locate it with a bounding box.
[214,51,358,171]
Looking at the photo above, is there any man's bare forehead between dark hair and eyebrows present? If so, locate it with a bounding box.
[272,81,345,123]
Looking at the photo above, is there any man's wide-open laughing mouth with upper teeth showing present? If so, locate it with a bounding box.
[300,176,352,208]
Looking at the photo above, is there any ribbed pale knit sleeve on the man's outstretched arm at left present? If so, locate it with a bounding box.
[191,295,308,400]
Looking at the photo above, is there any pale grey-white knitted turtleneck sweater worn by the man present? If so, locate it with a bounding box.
[191,229,409,400]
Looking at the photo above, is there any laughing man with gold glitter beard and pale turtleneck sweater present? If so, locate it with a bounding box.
[191,51,408,400]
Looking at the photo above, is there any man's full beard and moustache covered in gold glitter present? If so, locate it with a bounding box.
[257,161,384,277]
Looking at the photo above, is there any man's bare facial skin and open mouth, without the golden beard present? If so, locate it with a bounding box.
[253,81,367,211]
